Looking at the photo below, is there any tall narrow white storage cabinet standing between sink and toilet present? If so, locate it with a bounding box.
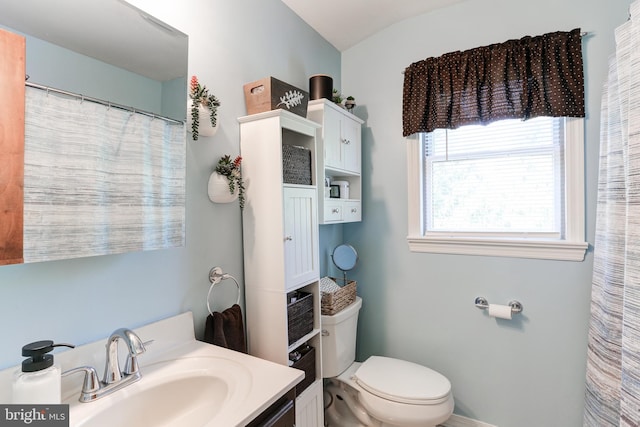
[238,110,324,427]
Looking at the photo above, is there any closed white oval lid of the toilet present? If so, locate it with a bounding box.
[354,356,451,405]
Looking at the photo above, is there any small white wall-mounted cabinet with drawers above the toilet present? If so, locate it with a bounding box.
[307,99,364,224]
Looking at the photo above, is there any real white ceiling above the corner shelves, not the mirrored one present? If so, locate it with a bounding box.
[282,0,463,52]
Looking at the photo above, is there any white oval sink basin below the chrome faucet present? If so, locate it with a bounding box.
[69,357,251,427]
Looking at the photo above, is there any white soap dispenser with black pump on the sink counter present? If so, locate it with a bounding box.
[13,340,74,404]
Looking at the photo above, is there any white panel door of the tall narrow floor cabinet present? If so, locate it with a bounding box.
[283,187,320,291]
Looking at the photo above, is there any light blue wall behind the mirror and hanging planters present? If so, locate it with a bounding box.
[0,0,340,369]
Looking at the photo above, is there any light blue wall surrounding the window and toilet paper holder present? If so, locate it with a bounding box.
[342,0,631,427]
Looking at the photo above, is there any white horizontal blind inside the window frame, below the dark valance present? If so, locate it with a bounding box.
[423,117,564,238]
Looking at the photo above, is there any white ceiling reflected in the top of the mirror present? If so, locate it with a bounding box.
[0,0,188,81]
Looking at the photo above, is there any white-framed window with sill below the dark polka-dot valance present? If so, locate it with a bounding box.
[408,117,587,261]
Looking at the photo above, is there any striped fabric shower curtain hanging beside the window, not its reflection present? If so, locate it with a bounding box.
[584,0,640,427]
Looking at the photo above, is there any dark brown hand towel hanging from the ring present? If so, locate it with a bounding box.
[204,304,247,353]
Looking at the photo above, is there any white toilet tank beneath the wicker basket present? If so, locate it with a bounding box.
[322,297,362,378]
